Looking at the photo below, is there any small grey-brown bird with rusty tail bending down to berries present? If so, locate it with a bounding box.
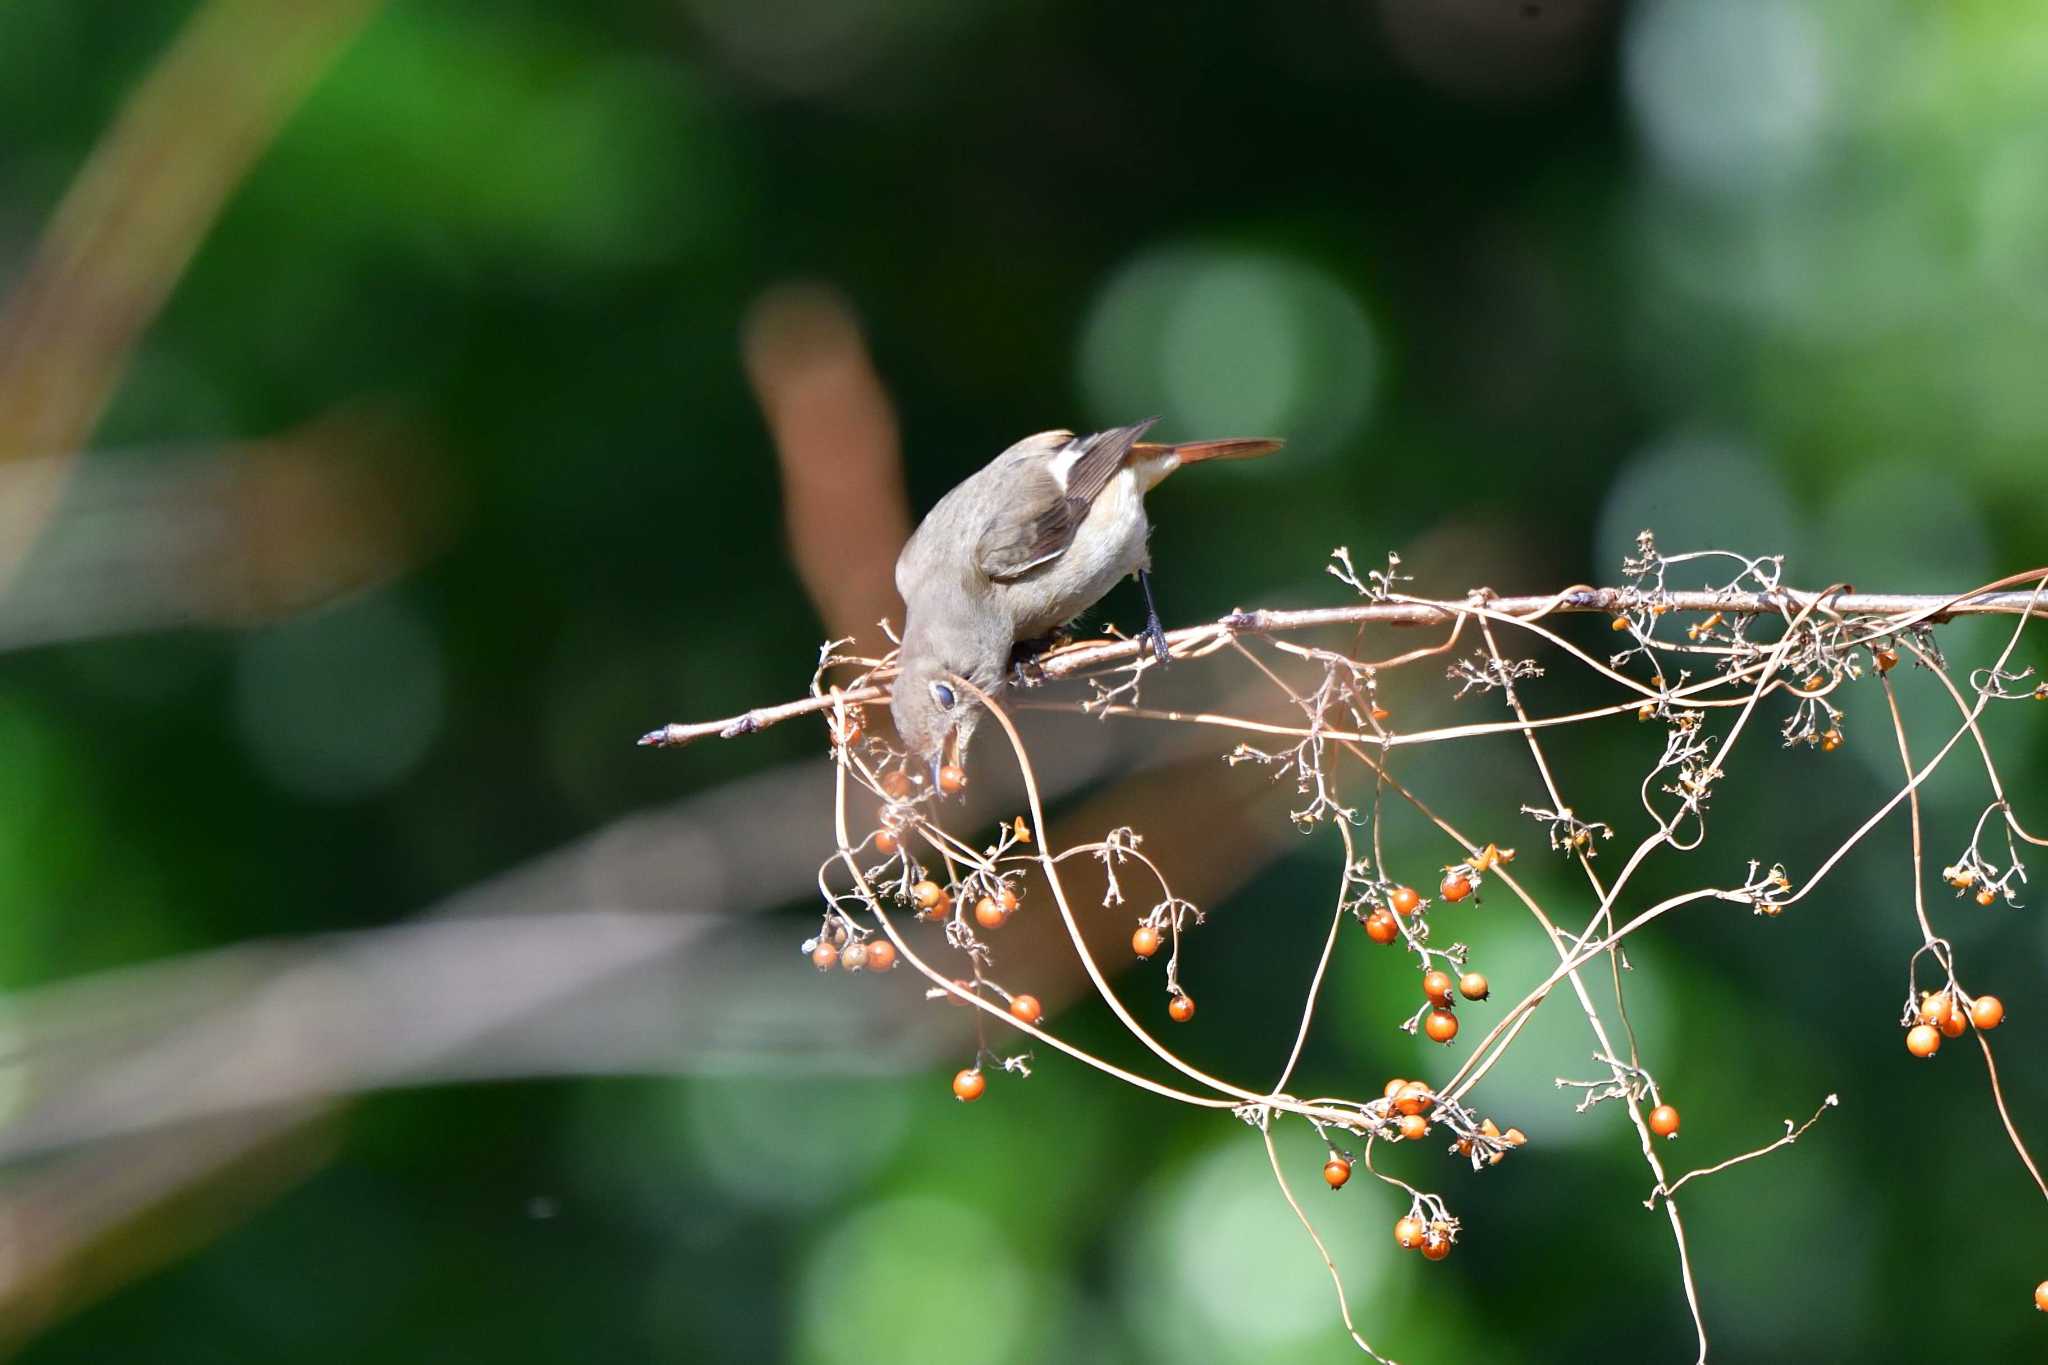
[889,417,1282,790]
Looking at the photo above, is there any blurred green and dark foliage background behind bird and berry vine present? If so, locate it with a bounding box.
[0,0,2048,1363]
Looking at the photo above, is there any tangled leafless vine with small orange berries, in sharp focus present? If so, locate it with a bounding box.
[647,532,2048,1361]
